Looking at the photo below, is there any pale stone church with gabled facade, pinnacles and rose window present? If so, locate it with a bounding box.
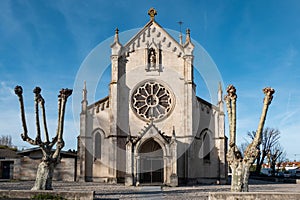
[77,8,227,186]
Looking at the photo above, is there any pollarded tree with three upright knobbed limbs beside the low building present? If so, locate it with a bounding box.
[15,86,72,190]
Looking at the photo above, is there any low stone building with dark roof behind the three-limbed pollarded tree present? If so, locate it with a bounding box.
[0,146,77,181]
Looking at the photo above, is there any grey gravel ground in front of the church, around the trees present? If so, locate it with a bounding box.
[0,180,300,200]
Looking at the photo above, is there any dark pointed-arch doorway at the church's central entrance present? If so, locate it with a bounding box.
[139,139,164,184]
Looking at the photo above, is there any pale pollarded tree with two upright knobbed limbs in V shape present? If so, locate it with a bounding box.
[225,85,275,192]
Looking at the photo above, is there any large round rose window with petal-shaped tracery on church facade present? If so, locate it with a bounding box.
[131,81,174,120]
